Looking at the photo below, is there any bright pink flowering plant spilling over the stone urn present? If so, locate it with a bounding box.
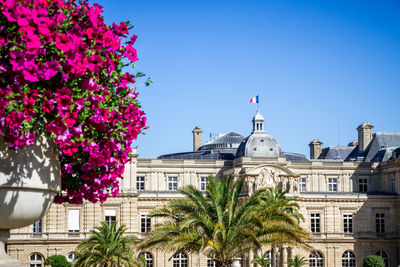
[0,0,151,203]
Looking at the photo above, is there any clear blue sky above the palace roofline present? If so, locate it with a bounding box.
[91,0,400,157]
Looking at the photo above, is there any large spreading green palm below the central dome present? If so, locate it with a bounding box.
[142,176,307,266]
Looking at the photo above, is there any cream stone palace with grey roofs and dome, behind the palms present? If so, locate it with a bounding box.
[7,112,400,267]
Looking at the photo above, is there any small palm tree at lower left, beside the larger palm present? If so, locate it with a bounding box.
[74,222,140,267]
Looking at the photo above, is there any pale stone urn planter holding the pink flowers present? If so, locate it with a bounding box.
[0,137,61,267]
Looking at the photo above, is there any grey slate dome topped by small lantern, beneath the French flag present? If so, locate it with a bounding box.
[236,110,282,158]
